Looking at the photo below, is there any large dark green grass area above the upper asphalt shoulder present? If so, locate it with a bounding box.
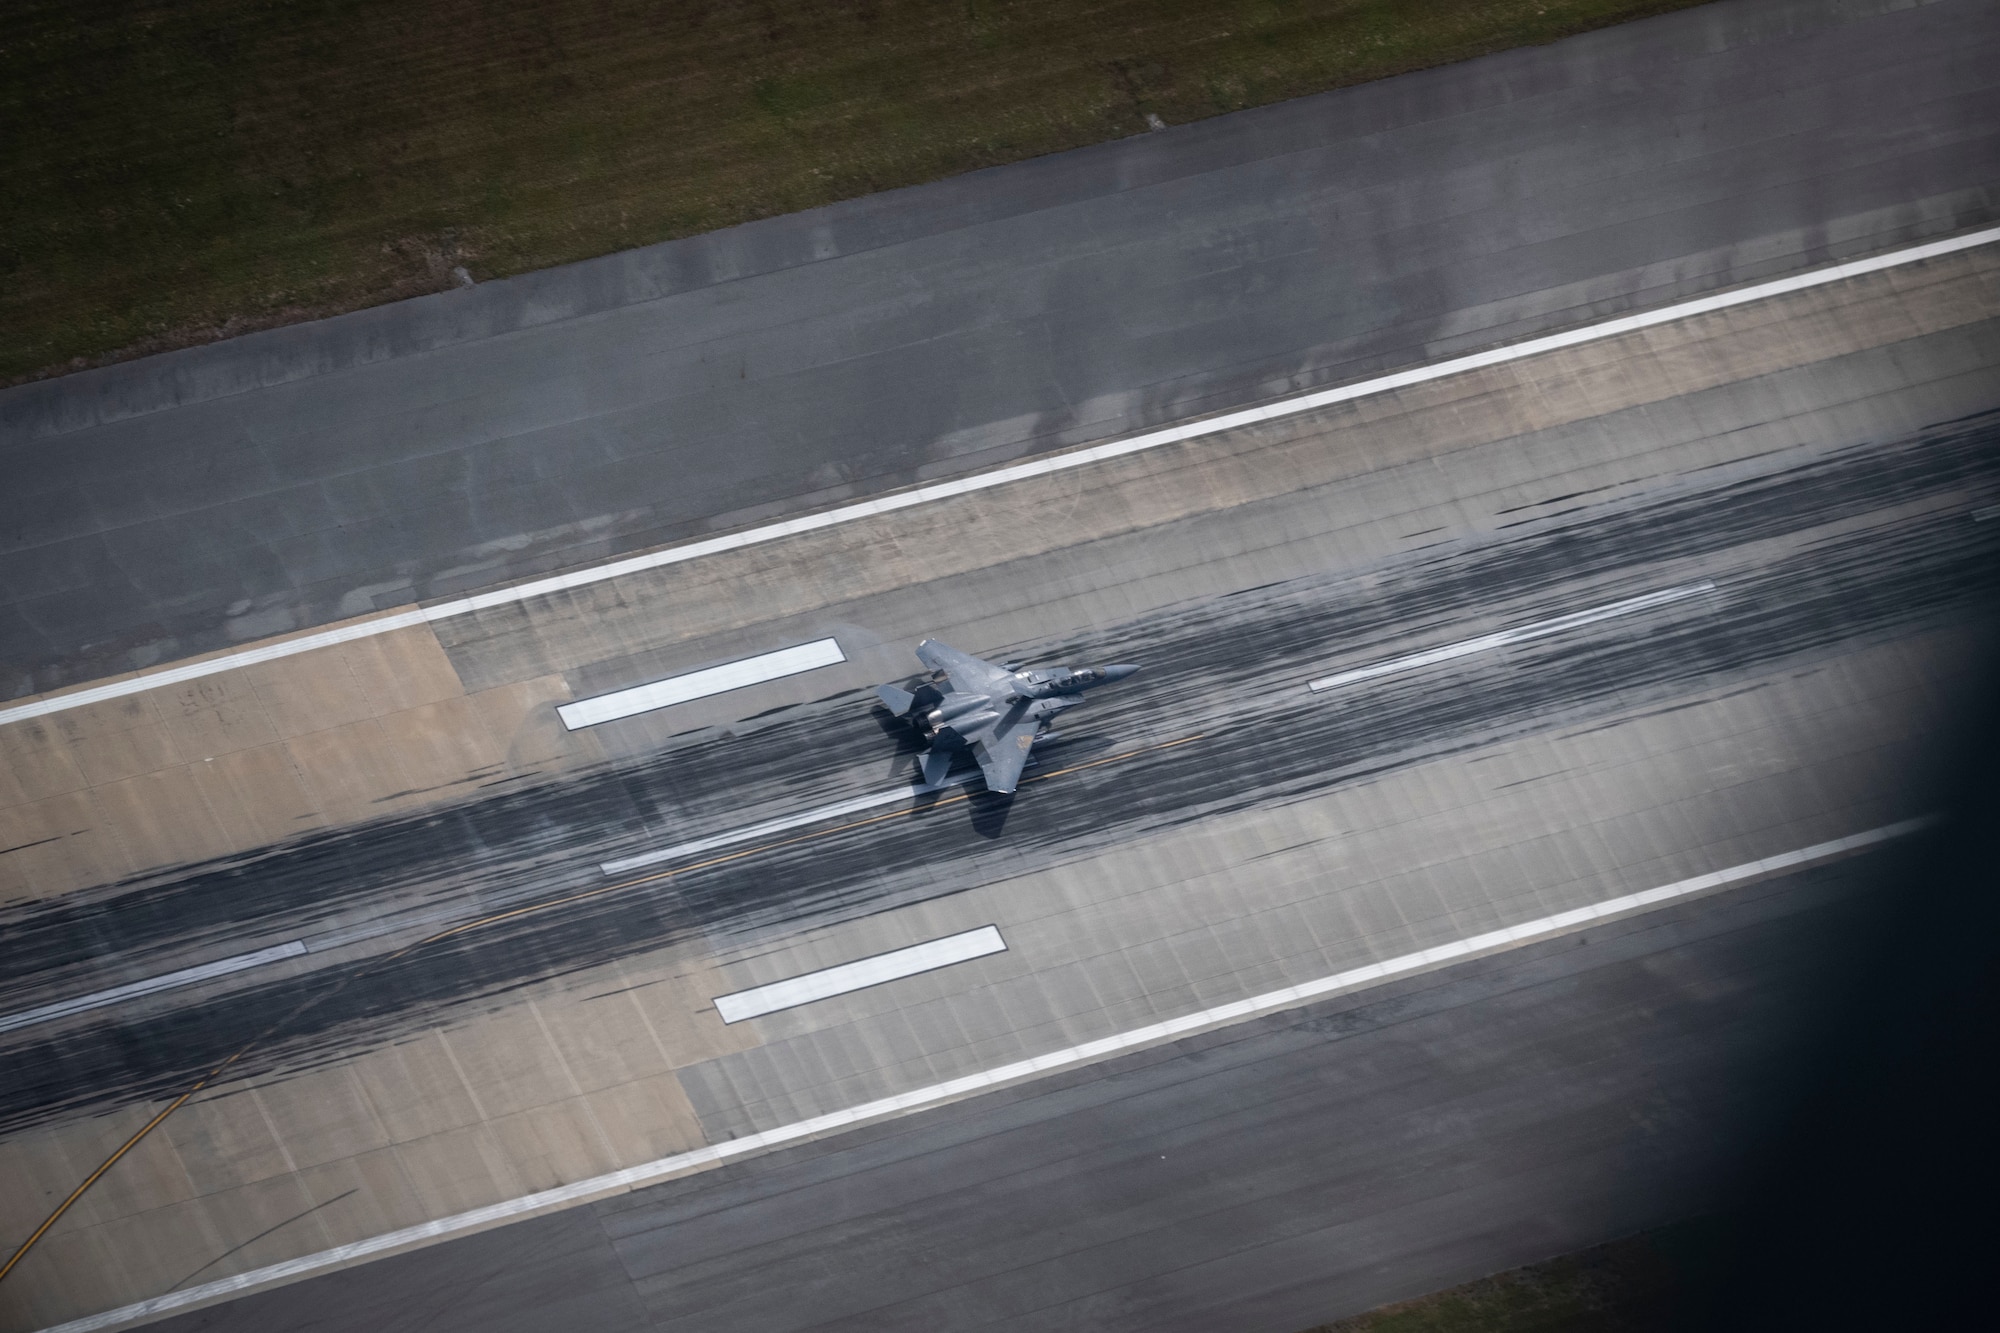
[0,0,1720,382]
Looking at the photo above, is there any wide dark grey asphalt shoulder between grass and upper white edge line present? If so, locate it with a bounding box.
[0,0,2000,697]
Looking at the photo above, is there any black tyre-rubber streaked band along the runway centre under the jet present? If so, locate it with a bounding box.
[0,412,2000,1129]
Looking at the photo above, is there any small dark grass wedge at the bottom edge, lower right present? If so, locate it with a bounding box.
[1308,1219,1730,1333]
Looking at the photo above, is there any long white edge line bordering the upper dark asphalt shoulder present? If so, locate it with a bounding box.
[0,226,2000,727]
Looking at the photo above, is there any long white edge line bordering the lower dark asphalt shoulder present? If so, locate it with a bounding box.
[27,815,1940,1333]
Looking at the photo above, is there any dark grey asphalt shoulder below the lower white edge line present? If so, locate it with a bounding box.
[154,857,1894,1333]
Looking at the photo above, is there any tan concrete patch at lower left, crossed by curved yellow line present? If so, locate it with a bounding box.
[0,955,756,1331]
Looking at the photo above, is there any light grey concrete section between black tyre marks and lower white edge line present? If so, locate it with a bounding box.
[682,632,1976,1139]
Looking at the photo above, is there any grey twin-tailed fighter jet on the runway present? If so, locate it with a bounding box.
[876,638,1138,793]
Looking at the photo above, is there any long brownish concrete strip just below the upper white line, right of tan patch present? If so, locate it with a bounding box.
[436,246,2000,685]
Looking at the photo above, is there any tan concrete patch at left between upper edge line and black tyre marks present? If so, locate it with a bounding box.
[0,626,600,903]
